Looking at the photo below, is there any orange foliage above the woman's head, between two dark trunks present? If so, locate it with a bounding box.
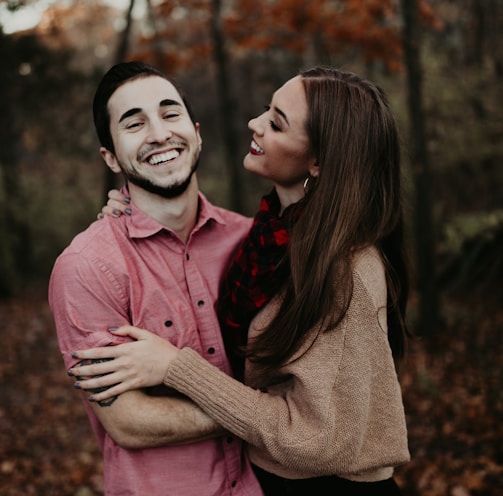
[225,0,408,69]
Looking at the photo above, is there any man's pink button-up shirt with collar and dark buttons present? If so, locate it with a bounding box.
[49,195,262,496]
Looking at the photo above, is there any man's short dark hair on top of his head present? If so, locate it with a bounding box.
[93,62,196,153]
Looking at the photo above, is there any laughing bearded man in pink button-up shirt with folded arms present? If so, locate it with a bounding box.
[49,62,262,496]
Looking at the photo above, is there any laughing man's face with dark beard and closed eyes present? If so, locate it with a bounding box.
[101,76,201,198]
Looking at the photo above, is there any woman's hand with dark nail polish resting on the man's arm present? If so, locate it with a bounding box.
[68,326,179,402]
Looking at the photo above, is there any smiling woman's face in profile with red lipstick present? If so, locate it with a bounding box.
[244,76,317,195]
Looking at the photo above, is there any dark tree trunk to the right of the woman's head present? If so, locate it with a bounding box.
[401,0,439,336]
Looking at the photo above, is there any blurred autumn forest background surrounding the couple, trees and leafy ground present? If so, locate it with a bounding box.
[0,0,503,496]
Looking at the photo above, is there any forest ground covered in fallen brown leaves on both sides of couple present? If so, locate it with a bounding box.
[0,289,503,496]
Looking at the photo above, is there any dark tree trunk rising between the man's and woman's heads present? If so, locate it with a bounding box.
[211,0,243,212]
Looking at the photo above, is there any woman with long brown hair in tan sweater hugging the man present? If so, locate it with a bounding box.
[73,67,409,496]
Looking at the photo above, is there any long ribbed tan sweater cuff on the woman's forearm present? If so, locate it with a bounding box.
[164,348,260,441]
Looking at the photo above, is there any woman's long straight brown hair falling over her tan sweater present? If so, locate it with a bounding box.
[247,67,408,372]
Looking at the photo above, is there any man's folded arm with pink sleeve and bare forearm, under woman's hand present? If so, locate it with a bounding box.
[49,254,224,449]
